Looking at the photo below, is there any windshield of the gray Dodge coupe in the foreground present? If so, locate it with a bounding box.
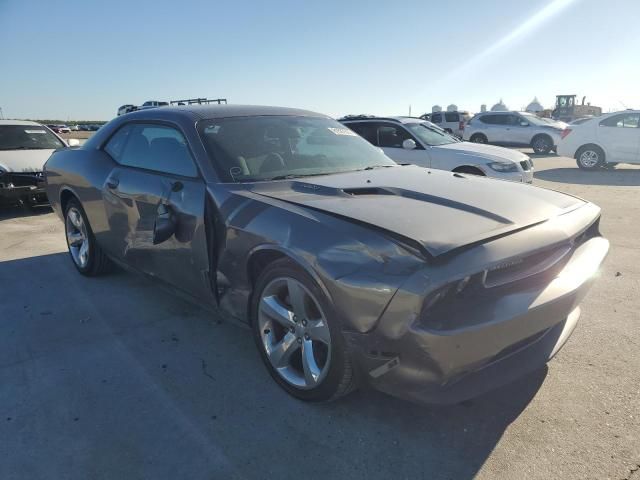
[198,116,396,182]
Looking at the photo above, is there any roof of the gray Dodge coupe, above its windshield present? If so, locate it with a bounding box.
[121,105,329,121]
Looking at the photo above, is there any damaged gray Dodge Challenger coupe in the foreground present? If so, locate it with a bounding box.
[45,105,609,403]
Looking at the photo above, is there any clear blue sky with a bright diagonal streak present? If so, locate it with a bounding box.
[0,0,640,120]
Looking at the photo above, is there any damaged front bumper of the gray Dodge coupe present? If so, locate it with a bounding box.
[345,230,609,404]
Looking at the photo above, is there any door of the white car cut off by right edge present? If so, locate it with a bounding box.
[598,112,640,163]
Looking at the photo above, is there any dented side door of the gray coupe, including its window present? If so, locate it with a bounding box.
[103,123,212,298]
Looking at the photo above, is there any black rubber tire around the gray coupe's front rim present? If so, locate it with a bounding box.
[250,258,357,402]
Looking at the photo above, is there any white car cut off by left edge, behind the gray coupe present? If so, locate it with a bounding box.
[0,120,79,205]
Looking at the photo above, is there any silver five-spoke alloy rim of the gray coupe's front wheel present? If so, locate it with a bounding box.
[258,278,331,390]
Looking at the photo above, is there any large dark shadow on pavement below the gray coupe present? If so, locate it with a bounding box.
[0,253,547,479]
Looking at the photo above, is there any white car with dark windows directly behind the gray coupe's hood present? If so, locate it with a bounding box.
[340,116,533,183]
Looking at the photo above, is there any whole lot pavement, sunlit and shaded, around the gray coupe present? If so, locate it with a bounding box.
[0,156,640,480]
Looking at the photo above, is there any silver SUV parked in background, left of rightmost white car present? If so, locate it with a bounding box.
[463,112,563,154]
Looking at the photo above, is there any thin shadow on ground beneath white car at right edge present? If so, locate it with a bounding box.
[534,166,640,186]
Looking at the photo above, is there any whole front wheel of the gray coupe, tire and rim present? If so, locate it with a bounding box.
[251,259,355,402]
